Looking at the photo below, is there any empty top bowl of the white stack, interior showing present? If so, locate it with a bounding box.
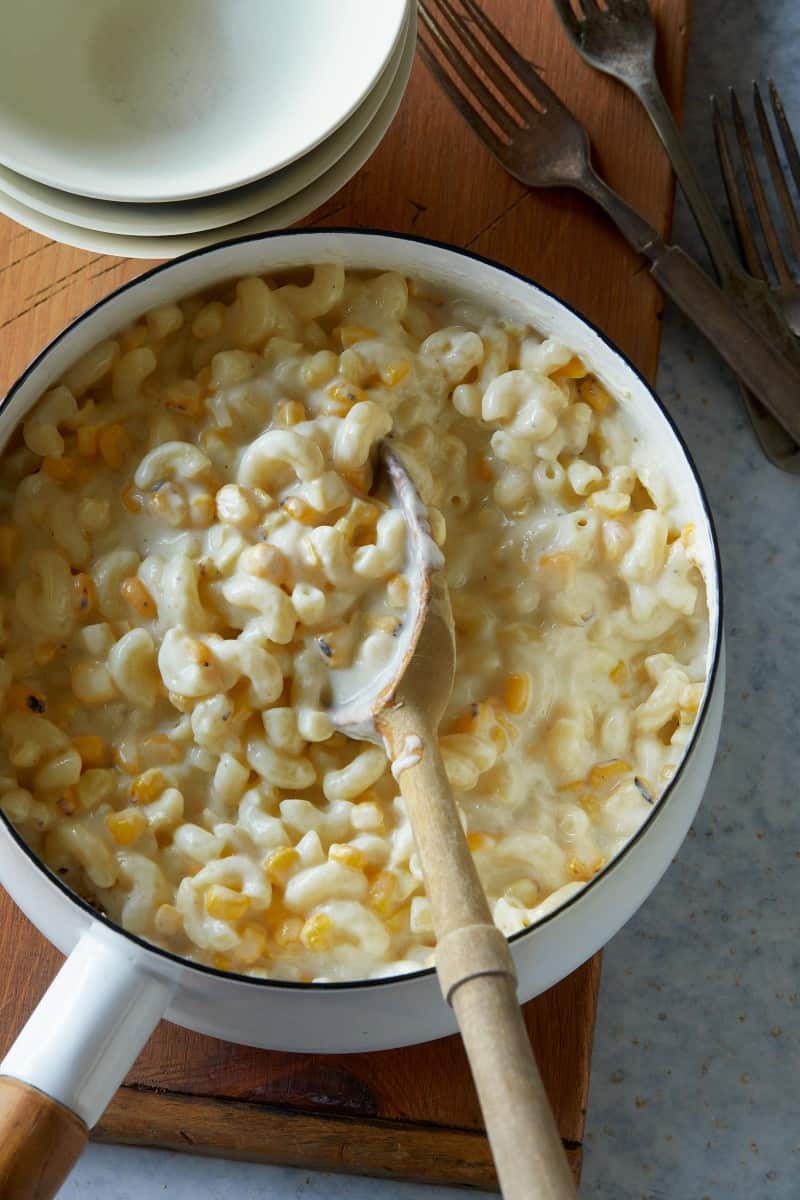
[0,0,408,202]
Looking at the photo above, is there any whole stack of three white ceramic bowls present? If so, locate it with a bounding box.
[0,0,416,258]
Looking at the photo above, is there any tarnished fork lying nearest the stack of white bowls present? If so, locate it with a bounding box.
[420,0,800,442]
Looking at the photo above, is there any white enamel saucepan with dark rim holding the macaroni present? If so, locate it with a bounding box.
[0,229,724,1196]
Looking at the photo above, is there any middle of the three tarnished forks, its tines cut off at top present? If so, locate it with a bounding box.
[553,0,800,473]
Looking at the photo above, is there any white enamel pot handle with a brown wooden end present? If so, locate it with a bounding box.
[0,924,176,1200]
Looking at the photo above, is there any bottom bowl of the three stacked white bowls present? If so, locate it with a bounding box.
[0,12,416,259]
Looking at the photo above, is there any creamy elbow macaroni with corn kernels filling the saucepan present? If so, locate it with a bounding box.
[0,264,708,982]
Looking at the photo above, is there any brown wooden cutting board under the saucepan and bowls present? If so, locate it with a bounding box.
[0,0,690,1188]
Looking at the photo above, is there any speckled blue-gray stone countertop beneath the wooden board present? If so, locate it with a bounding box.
[62,0,800,1200]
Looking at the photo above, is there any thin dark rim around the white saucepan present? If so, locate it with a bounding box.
[0,226,723,994]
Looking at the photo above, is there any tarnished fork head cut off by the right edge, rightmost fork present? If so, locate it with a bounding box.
[711,79,800,336]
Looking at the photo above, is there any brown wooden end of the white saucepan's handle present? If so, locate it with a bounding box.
[0,1075,89,1200]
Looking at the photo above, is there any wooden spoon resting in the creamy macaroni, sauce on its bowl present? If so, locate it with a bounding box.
[331,443,577,1200]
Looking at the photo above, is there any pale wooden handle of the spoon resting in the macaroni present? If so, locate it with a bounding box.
[379,704,577,1200]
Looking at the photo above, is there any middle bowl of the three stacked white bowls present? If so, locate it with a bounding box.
[0,13,411,238]
